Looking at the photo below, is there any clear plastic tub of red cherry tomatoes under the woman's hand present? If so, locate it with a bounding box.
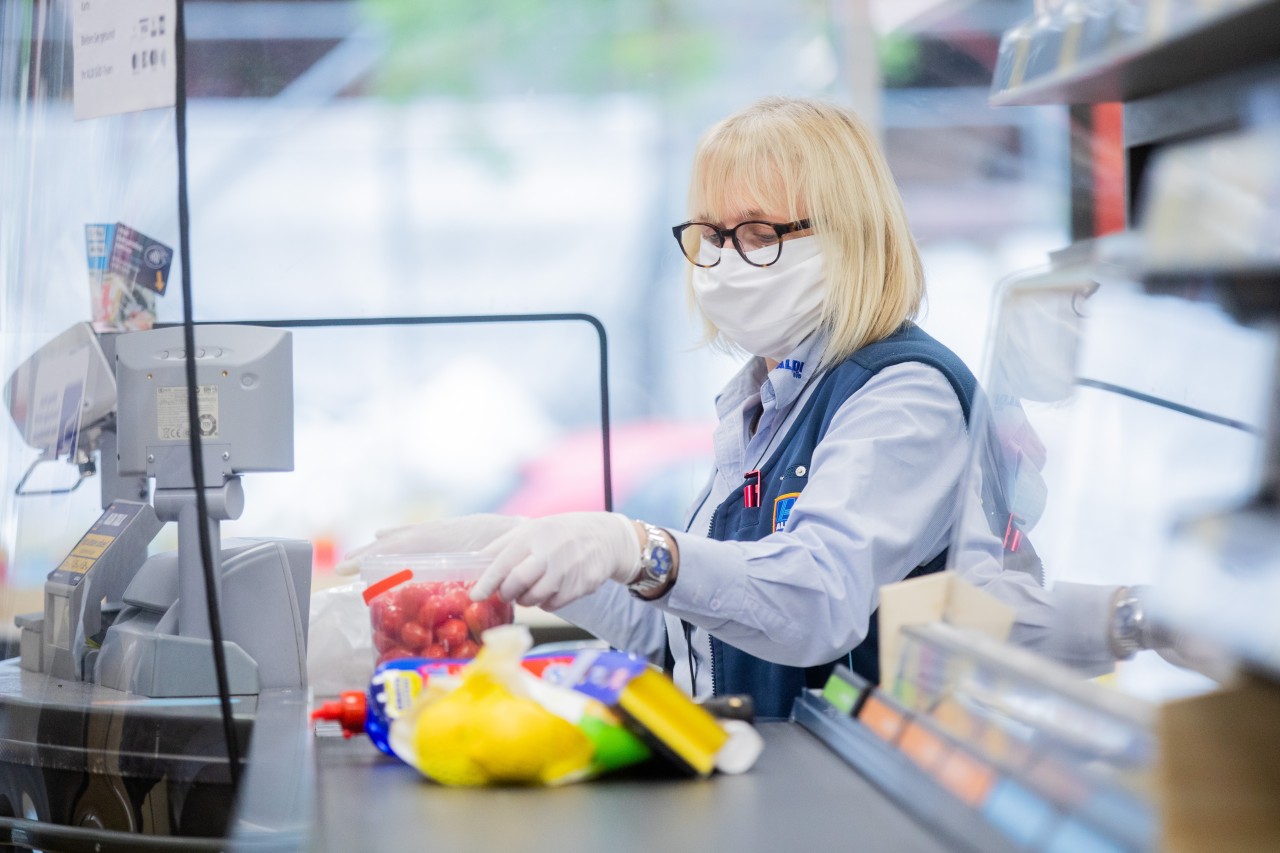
[360,552,515,663]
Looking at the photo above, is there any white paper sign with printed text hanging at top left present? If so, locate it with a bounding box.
[72,0,177,120]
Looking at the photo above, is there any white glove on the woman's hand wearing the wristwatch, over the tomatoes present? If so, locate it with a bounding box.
[471,512,640,610]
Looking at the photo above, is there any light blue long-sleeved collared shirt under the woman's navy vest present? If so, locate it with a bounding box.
[558,334,1114,697]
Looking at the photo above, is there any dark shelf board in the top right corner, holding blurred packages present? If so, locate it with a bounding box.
[991,0,1280,106]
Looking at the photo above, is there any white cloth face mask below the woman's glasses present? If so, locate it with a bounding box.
[694,236,827,361]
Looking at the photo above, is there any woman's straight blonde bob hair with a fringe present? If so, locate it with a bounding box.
[689,97,924,365]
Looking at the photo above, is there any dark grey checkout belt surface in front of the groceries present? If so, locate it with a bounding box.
[312,722,947,853]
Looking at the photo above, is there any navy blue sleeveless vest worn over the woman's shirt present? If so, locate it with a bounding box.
[686,324,977,717]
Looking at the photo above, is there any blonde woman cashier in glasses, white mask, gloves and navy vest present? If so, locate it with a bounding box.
[337,97,1131,717]
